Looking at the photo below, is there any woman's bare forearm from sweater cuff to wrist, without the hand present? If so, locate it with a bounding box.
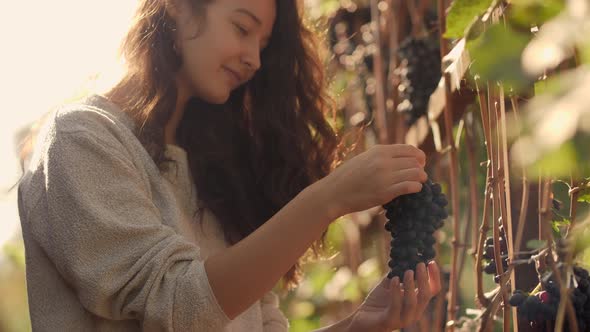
[205,183,338,319]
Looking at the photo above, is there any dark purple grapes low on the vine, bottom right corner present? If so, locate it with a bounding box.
[509,266,590,332]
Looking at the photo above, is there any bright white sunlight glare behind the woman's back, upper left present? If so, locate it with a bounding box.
[0,0,136,253]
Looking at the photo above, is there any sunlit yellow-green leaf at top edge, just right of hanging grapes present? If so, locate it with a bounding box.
[445,0,493,39]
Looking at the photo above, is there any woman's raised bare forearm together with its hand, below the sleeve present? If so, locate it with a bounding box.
[205,145,427,319]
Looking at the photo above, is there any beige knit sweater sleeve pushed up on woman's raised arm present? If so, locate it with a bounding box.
[32,125,230,331]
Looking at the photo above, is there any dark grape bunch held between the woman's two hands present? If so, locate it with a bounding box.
[383,179,448,280]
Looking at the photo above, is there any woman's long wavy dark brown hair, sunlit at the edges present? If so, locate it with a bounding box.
[97,0,341,288]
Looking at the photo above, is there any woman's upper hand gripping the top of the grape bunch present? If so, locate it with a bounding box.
[317,144,428,218]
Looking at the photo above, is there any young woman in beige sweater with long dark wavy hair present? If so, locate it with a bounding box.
[19,0,440,331]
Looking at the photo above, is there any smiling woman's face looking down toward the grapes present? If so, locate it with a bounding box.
[171,0,276,104]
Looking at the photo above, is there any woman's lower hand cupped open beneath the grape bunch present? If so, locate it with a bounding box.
[347,262,441,332]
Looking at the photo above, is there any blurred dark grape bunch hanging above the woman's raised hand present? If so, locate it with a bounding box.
[396,37,441,126]
